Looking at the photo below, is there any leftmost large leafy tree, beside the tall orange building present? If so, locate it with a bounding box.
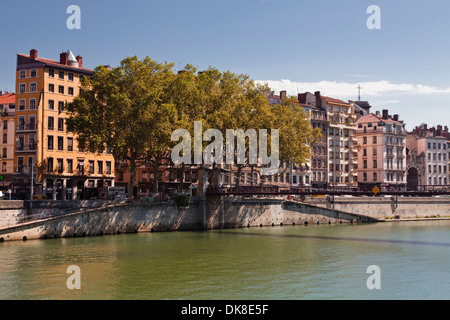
[67,56,177,195]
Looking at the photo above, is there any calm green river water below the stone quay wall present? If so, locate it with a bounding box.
[0,221,450,300]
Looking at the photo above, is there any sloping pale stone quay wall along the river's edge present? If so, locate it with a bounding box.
[0,197,450,241]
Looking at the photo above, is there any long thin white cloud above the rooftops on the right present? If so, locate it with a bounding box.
[256,79,450,99]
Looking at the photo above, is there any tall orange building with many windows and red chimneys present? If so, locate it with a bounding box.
[14,49,114,200]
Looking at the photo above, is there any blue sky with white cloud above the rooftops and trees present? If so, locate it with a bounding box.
[0,0,450,130]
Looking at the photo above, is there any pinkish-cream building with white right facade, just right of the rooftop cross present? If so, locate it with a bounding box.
[356,110,407,190]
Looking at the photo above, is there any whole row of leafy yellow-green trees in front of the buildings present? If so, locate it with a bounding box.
[67,56,318,194]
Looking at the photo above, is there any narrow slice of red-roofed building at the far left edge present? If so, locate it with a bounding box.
[0,91,16,191]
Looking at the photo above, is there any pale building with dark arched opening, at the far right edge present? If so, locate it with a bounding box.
[406,124,450,187]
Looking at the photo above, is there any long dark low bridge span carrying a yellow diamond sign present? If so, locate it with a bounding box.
[206,185,450,197]
